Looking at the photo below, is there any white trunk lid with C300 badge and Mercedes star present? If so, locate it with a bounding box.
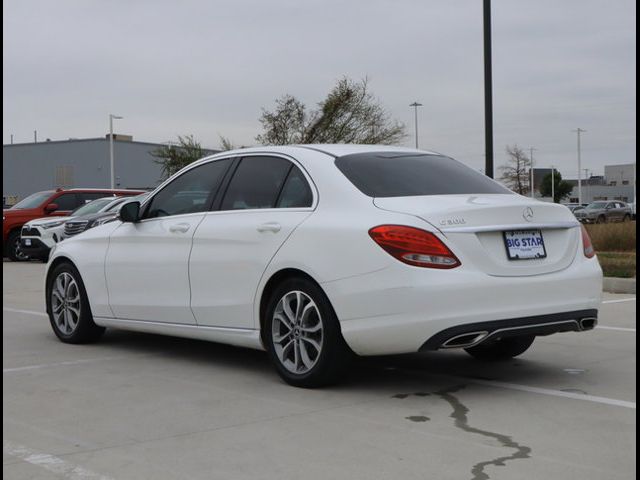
[373,194,580,276]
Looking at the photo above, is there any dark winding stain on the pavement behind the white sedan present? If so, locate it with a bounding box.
[392,385,531,480]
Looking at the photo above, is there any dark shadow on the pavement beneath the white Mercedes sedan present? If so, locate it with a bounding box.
[97,330,567,390]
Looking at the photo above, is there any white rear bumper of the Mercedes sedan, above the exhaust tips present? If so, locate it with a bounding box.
[322,256,602,355]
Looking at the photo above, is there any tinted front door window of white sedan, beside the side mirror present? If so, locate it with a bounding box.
[144,159,231,218]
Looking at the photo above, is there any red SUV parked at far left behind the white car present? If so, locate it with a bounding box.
[2,188,145,261]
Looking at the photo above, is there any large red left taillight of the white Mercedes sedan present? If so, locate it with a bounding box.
[369,225,460,268]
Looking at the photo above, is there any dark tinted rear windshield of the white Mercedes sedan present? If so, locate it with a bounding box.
[336,153,512,197]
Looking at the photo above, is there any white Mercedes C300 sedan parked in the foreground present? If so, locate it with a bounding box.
[46,145,602,387]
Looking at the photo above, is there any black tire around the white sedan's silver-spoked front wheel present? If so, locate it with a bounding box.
[46,262,105,343]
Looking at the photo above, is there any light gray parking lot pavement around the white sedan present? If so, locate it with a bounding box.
[2,262,636,480]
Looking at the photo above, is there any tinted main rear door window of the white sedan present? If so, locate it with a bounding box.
[220,157,293,210]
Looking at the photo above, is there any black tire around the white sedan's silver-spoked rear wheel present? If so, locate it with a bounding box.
[262,277,354,388]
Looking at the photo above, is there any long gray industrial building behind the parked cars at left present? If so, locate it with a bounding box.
[2,135,218,205]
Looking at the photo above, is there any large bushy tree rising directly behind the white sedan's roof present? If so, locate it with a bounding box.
[256,77,406,145]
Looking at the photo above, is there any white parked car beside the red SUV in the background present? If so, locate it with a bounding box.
[20,196,136,262]
